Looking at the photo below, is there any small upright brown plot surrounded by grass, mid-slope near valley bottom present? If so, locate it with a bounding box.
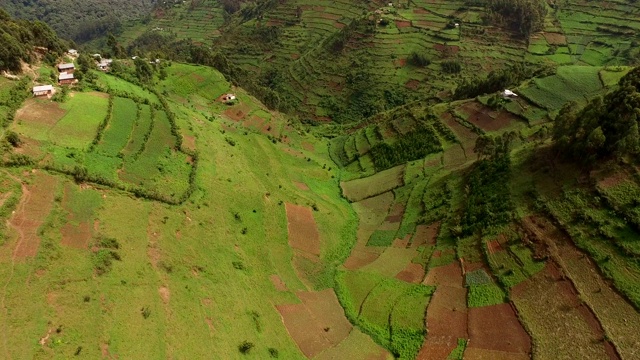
[285,203,320,255]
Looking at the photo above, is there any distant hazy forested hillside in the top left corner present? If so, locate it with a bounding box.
[0,0,155,42]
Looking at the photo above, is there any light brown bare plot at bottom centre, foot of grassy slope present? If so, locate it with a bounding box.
[276,289,352,358]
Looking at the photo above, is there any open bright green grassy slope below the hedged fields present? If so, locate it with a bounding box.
[0,64,368,358]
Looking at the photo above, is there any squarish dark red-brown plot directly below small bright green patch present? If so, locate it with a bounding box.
[469,304,531,354]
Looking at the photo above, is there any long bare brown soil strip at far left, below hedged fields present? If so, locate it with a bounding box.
[10,172,58,258]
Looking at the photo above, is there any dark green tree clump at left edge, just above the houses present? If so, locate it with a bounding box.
[0,9,68,71]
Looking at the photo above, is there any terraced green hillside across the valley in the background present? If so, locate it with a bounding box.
[119,0,640,122]
